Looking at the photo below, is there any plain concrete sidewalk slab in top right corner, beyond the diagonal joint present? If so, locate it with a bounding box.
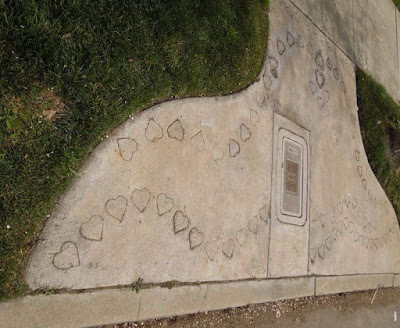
[291,0,400,101]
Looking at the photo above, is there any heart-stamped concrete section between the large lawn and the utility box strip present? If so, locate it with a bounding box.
[27,83,272,288]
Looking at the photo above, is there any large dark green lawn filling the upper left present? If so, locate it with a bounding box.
[0,0,268,300]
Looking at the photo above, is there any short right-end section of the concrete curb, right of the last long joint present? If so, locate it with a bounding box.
[315,274,394,296]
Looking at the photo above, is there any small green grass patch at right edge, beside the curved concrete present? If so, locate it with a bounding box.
[357,69,400,223]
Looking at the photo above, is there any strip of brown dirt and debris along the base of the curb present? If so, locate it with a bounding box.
[101,288,400,328]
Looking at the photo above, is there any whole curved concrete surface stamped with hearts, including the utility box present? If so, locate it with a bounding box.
[26,0,400,289]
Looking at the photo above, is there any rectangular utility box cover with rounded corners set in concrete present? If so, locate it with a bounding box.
[277,129,307,225]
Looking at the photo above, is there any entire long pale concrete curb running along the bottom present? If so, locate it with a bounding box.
[0,274,394,328]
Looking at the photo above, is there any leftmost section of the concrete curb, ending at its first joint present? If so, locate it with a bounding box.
[0,289,140,328]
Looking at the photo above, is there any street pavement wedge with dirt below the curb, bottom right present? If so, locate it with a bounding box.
[119,288,400,328]
